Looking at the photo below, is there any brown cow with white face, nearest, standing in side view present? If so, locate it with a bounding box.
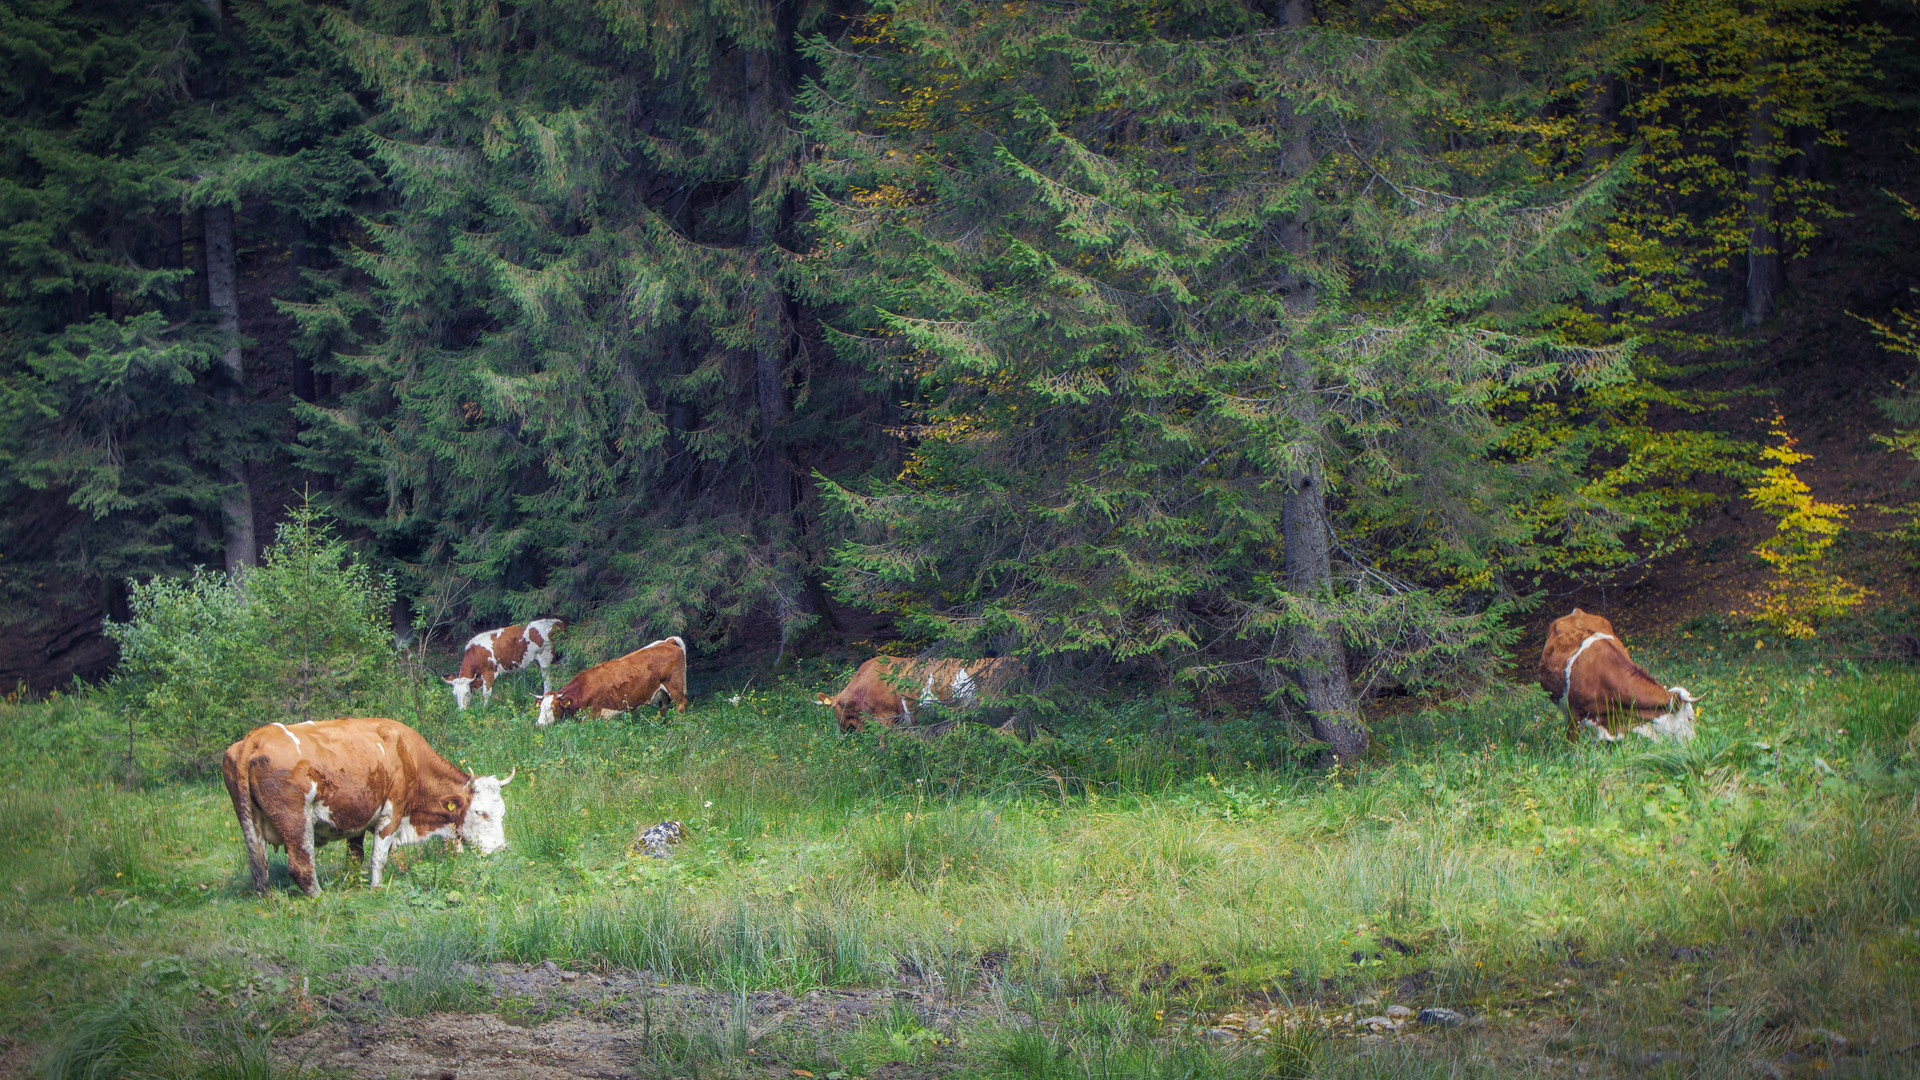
[221,717,513,896]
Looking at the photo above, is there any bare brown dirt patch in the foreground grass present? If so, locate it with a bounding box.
[275,961,1025,1080]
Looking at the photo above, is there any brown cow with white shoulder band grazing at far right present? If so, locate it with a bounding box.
[1540,607,1705,742]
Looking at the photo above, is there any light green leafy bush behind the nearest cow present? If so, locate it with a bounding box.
[106,507,396,773]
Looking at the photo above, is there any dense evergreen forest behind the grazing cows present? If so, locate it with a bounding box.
[0,0,1920,753]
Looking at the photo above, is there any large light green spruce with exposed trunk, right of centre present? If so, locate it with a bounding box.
[806,2,1622,759]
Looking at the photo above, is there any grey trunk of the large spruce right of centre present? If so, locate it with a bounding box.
[1279,0,1367,761]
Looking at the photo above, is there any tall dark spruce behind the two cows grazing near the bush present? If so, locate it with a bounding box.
[290,2,872,655]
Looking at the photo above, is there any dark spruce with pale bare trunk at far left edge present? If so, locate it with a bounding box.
[0,0,372,638]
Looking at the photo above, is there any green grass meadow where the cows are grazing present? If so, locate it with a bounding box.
[0,638,1920,1080]
